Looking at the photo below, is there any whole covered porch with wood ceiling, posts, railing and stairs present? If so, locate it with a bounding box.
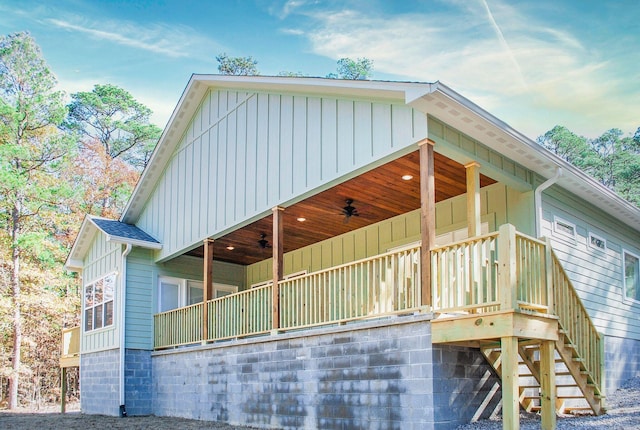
[154,140,603,429]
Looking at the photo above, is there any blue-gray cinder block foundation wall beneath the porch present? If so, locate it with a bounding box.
[152,315,500,430]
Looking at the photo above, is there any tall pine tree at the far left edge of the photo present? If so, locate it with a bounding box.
[0,33,79,407]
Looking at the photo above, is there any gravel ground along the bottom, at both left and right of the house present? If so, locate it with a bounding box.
[0,377,640,430]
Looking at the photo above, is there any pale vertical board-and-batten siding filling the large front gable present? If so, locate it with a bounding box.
[136,90,427,260]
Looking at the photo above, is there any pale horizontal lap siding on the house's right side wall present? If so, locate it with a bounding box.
[542,186,640,340]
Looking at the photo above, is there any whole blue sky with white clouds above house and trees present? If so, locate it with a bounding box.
[0,0,640,138]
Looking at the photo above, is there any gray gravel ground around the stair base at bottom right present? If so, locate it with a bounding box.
[458,377,640,430]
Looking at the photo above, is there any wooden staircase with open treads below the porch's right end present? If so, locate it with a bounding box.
[480,329,605,415]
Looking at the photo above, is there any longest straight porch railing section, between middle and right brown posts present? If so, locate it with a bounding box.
[278,246,420,329]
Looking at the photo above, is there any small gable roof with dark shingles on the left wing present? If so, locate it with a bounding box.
[64,215,162,270]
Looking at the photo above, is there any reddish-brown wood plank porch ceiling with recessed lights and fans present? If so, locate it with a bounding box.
[187,151,496,265]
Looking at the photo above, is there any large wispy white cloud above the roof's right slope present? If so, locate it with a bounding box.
[284,0,640,137]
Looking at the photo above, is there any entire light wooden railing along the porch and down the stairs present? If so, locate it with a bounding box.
[155,225,601,381]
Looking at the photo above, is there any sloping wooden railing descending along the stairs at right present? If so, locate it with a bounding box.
[550,251,604,389]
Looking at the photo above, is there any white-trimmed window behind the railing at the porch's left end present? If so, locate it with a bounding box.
[158,276,238,312]
